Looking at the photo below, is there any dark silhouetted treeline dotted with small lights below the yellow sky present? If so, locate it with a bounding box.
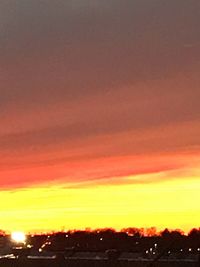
[13,228,200,254]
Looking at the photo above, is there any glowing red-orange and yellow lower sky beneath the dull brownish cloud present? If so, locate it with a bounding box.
[0,152,200,231]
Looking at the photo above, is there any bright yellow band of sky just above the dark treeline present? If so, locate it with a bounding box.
[0,174,200,231]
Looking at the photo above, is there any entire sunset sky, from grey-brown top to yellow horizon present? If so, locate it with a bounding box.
[0,0,200,231]
